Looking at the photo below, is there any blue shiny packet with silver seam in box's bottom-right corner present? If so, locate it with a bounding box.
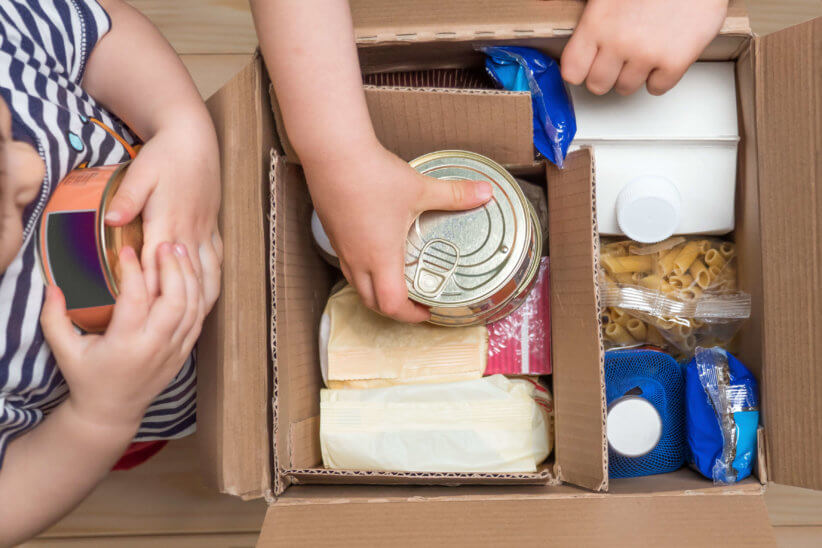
[685,347,759,484]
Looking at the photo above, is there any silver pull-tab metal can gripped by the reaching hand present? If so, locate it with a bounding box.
[405,150,542,326]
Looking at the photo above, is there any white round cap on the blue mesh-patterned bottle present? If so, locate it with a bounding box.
[606,396,662,457]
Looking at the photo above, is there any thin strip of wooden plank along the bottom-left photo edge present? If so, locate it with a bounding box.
[22,533,257,548]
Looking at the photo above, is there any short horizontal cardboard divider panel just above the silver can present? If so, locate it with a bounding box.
[365,86,534,165]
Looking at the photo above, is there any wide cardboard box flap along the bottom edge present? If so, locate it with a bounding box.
[257,487,776,548]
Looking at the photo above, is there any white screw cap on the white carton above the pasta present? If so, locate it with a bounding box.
[616,175,681,244]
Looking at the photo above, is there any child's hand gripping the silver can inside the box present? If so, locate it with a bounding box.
[303,145,491,322]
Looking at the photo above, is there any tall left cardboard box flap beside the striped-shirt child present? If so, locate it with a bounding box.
[197,55,275,498]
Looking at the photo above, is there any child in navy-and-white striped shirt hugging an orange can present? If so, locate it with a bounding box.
[0,0,222,546]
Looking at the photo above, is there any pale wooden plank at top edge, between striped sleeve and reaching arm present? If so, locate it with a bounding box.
[126,0,257,54]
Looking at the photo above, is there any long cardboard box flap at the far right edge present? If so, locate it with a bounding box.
[756,18,822,489]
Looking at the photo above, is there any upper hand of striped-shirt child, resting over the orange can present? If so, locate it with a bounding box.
[106,117,223,310]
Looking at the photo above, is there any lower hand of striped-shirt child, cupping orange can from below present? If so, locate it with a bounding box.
[40,243,206,435]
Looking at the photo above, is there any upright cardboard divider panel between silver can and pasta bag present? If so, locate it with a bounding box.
[547,148,608,491]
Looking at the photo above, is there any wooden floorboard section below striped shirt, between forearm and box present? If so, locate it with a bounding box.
[37,436,266,537]
